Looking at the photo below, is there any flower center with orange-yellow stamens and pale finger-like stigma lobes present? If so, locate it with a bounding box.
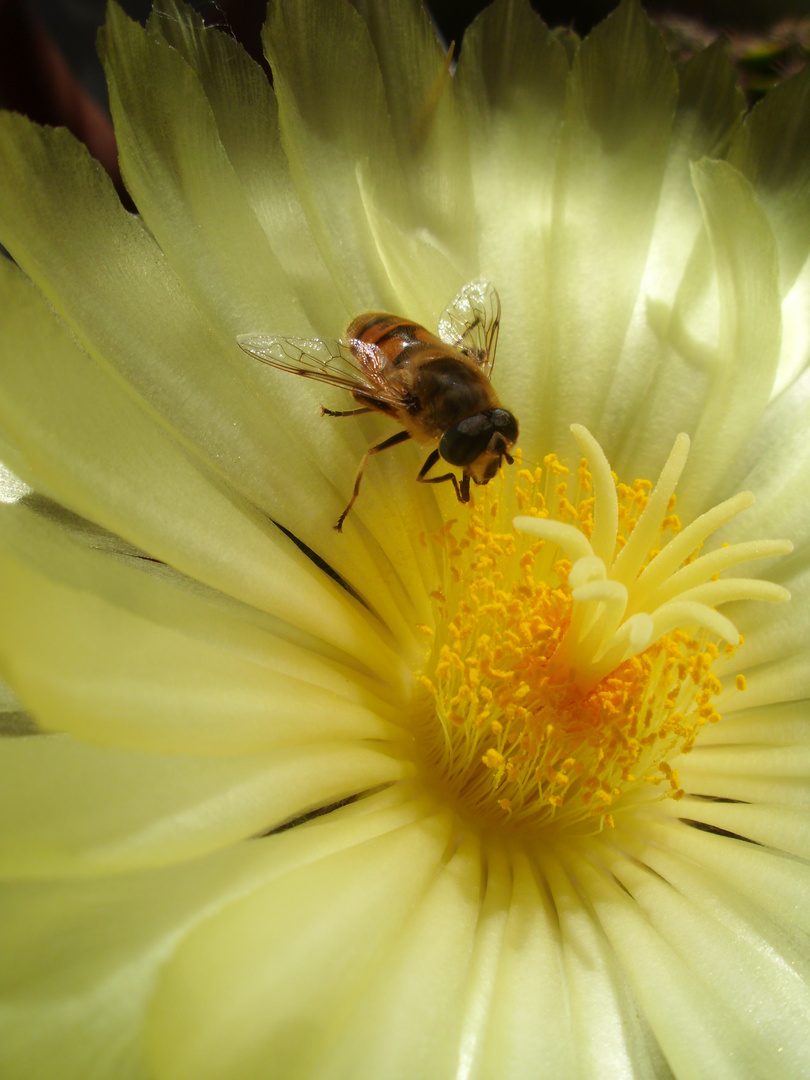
[416,424,792,829]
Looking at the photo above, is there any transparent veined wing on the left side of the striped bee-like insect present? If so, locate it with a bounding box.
[237,334,404,408]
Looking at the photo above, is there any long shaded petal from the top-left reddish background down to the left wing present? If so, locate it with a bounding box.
[99,3,312,337]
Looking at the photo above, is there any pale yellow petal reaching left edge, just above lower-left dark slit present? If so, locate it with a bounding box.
[0,735,408,879]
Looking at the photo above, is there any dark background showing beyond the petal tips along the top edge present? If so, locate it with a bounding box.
[0,0,810,196]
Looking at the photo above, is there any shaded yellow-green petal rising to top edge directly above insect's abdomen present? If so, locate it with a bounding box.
[264,0,427,321]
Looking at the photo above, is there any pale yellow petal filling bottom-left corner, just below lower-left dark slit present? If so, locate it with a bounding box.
[0,796,432,1080]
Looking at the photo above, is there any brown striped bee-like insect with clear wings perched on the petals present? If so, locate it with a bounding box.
[237,281,517,532]
